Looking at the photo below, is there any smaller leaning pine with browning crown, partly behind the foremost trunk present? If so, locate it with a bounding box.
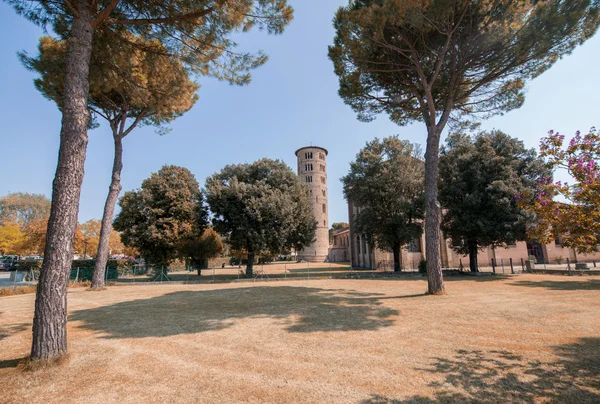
[20,34,198,289]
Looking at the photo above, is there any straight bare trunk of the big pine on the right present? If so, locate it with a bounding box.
[425,125,446,294]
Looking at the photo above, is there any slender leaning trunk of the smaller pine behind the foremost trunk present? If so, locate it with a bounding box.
[92,133,123,289]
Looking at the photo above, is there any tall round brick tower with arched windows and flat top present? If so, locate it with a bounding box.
[296,146,329,262]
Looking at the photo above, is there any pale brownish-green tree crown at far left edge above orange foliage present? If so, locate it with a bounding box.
[0,192,50,230]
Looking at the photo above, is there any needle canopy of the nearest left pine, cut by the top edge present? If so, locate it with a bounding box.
[6,0,293,85]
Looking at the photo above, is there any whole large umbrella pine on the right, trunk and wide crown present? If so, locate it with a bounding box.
[329,0,600,294]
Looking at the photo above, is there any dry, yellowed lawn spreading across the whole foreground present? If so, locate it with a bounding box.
[0,275,600,404]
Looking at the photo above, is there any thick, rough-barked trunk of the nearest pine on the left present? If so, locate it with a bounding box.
[31,5,93,360]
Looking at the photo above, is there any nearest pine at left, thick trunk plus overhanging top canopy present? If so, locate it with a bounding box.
[5,0,293,360]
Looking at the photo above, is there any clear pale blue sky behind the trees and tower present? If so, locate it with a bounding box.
[0,0,600,223]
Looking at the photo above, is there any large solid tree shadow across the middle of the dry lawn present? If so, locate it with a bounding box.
[69,286,403,338]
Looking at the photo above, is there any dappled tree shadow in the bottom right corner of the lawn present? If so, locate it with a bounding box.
[363,338,600,404]
